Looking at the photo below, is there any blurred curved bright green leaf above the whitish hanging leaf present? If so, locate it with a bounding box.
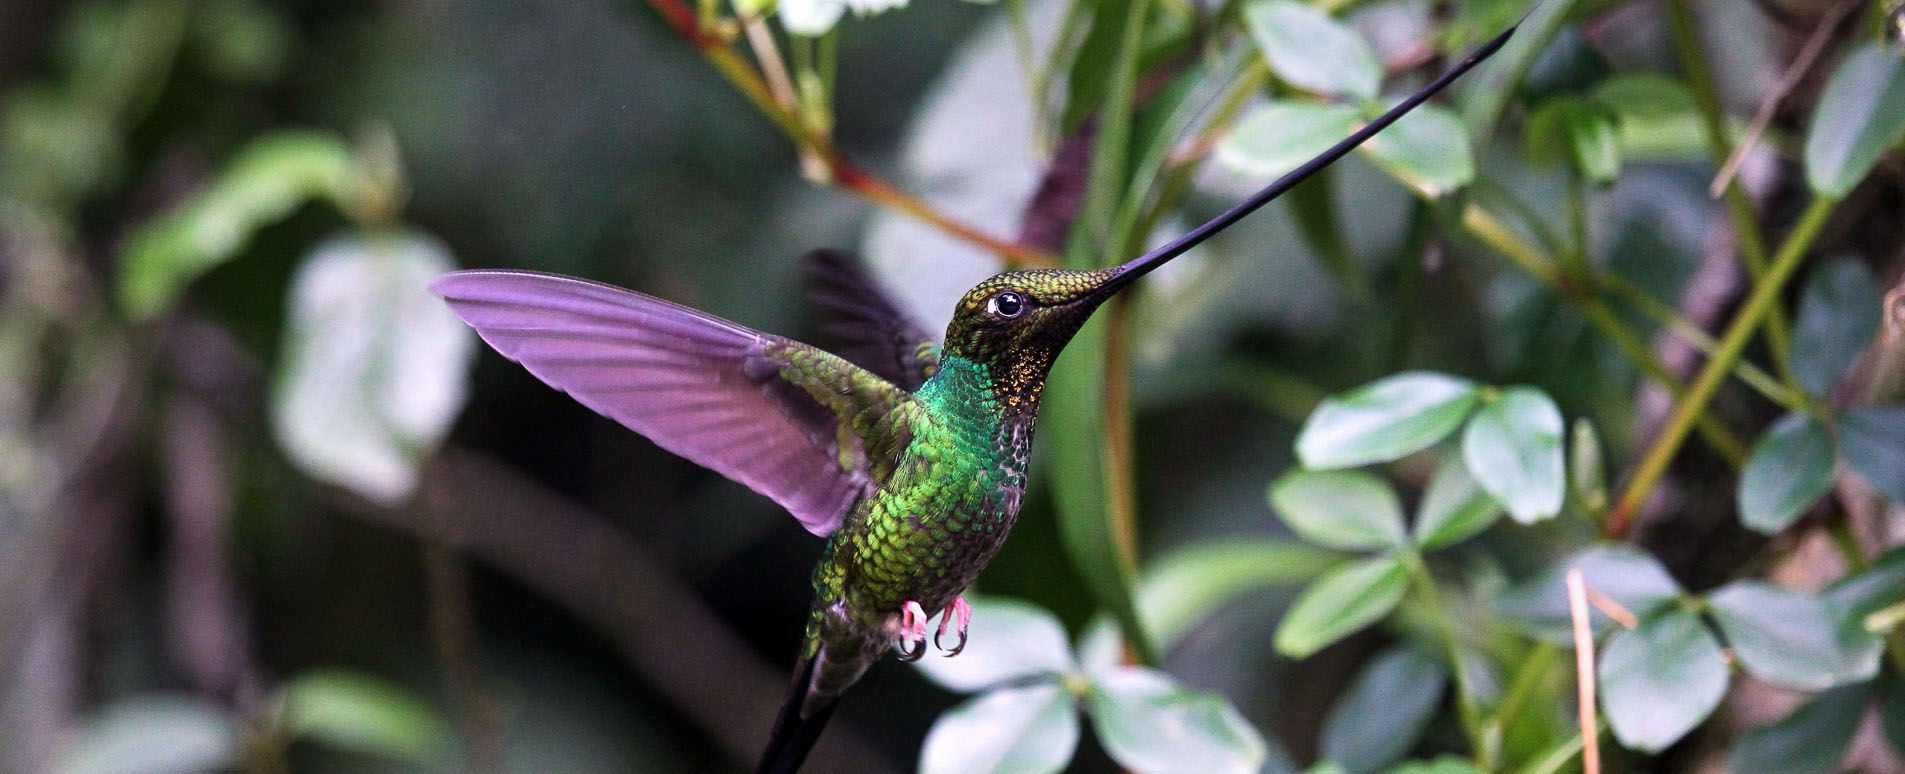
[118,132,360,320]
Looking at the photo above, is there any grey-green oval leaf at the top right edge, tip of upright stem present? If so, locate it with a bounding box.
[1806,42,1905,198]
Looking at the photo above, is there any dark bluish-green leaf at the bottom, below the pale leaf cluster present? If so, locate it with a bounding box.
[1318,644,1448,774]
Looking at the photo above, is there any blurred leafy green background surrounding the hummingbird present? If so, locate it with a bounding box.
[11,0,1905,772]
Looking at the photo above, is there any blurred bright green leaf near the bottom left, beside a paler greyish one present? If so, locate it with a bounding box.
[282,669,450,761]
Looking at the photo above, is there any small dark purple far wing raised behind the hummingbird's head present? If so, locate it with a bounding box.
[804,250,939,391]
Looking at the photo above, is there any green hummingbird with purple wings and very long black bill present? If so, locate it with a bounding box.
[431,27,1514,772]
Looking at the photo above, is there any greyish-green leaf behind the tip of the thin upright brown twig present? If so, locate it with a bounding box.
[1497,543,1680,642]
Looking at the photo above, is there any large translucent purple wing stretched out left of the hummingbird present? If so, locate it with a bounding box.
[431,271,909,536]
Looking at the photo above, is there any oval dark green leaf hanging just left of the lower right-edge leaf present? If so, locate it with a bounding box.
[1739,414,1835,534]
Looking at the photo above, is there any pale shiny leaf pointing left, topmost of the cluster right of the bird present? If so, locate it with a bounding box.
[1297,372,1476,469]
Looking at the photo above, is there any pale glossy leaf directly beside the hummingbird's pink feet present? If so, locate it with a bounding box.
[914,595,1078,694]
